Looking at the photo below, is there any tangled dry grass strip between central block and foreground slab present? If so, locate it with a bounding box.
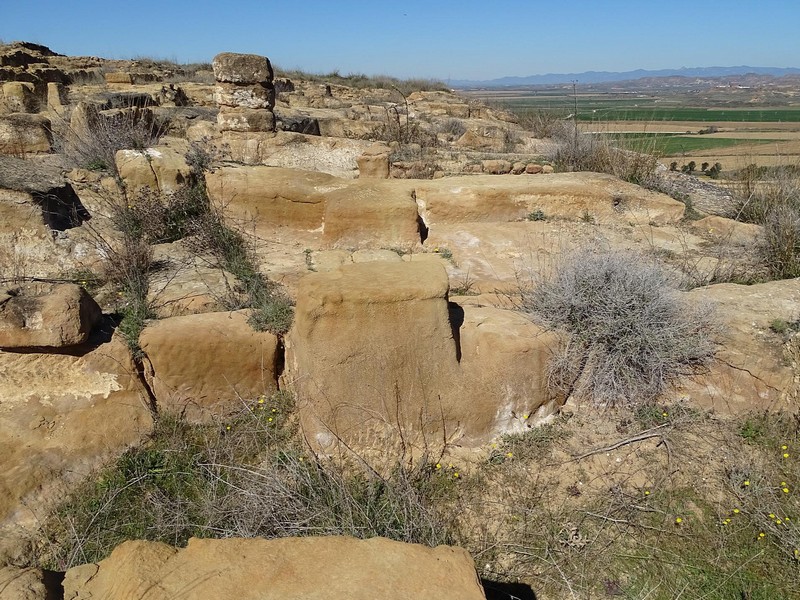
[46,393,453,570]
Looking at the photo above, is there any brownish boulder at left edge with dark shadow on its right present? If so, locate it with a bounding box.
[0,283,102,349]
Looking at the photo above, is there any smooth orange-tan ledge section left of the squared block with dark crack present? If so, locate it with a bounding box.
[206,166,348,229]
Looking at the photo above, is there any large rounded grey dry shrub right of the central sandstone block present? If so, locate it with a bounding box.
[522,250,715,405]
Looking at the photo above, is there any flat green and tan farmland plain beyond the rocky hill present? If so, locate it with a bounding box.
[465,86,800,170]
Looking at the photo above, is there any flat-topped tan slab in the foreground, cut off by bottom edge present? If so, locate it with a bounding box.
[64,536,484,600]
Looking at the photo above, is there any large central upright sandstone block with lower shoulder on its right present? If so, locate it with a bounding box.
[281,257,560,448]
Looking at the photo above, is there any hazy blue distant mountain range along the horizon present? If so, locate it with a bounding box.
[449,65,800,88]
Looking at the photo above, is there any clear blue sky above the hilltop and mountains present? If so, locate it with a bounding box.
[0,0,800,80]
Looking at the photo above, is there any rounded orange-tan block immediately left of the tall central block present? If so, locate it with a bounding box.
[140,311,278,421]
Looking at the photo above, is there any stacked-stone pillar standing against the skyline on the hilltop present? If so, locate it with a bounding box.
[212,52,275,131]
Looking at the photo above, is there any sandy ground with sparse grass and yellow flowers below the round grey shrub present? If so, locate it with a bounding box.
[460,404,800,600]
